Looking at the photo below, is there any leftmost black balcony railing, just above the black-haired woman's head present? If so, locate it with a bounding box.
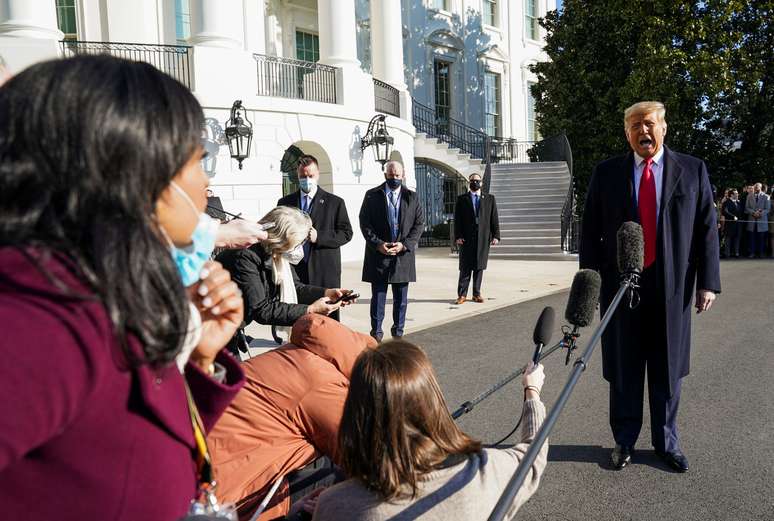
[60,40,191,89]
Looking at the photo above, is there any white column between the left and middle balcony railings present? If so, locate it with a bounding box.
[191,0,244,49]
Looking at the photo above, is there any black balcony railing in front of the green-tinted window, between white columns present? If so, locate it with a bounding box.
[253,54,337,103]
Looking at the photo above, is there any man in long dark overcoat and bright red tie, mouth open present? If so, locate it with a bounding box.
[580,102,720,472]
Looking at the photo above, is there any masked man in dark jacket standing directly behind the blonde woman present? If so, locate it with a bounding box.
[277,154,352,320]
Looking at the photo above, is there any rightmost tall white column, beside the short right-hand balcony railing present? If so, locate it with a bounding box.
[371,0,406,90]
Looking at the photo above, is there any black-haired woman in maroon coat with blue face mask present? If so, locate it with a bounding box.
[0,56,243,521]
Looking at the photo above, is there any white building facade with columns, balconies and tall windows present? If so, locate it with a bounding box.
[0,0,555,260]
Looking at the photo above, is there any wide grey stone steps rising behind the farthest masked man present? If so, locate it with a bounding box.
[489,161,577,260]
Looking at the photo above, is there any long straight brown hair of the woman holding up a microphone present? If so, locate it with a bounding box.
[339,340,481,501]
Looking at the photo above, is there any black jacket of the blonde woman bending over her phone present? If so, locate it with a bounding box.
[216,243,325,326]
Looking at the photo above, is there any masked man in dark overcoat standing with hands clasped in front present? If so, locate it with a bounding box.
[360,161,425,341]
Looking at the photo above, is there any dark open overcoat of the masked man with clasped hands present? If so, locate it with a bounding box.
[360,183,425,283]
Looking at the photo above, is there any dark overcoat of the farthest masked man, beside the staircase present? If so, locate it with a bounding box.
[454,192,500,271]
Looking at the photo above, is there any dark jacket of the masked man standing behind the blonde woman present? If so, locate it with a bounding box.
[277,186,352,288]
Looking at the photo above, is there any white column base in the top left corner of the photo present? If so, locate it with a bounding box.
[0,0,64,40]
